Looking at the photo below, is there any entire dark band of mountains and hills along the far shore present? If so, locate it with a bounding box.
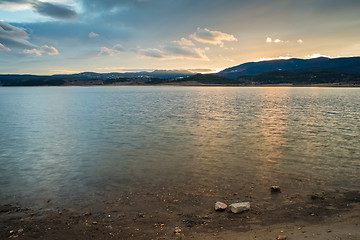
[0,57,360,86]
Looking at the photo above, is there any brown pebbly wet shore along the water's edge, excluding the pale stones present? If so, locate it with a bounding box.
[0,191,360,239]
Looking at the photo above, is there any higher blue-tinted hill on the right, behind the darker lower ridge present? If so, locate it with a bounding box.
[216,57,360,79]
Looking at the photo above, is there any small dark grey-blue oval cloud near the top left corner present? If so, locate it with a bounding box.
[32,2,78,20]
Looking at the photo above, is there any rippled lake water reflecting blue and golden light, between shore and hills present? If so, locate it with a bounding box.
[0,87,360,209]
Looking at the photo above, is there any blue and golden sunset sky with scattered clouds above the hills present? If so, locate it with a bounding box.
[0,0,360,75]
